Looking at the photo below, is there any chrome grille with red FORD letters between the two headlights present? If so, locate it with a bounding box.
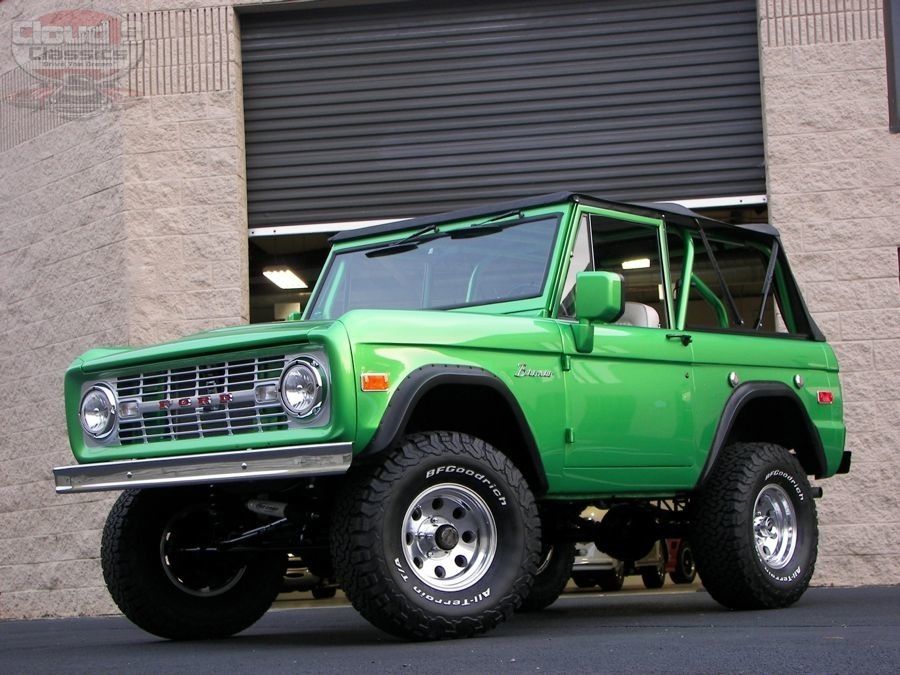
[116,355,288,445]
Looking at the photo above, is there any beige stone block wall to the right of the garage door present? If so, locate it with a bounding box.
[759,0,900,585]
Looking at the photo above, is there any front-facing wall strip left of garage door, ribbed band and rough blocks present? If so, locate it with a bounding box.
[123,3,249,344]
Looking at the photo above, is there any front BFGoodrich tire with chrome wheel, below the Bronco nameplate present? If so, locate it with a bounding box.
[331,432,540,640]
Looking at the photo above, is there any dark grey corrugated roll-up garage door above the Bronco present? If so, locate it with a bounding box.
[241,0,765,227]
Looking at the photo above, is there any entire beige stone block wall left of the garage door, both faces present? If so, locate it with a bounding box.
[0,0,248,620]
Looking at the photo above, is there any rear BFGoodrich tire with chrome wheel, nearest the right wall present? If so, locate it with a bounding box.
[691,443,819,609]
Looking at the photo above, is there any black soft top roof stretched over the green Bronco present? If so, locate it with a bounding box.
[331,192,778,243]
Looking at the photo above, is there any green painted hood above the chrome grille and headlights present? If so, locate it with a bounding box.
[73,321,334,373]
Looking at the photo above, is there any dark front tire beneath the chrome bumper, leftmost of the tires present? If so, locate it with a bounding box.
[101,488,286,640]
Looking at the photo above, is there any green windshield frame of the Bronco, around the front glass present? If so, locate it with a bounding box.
[303,211,570,320]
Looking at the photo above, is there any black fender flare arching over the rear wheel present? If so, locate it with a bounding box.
[695,381,828,489]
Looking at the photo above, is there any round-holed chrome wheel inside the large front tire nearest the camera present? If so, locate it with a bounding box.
[400,483,497,591]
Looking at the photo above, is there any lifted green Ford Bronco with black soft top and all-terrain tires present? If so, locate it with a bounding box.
[55,193,850,639]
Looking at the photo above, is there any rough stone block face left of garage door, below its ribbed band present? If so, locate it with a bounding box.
[123,91,249,344]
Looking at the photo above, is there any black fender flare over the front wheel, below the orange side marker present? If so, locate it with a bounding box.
[360,364,548,494]
